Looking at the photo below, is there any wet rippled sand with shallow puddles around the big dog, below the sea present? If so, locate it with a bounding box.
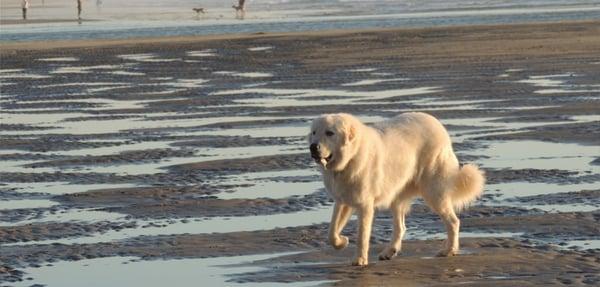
[0,21,600,286]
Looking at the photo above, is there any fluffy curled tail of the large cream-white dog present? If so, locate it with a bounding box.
[451,164,485,211]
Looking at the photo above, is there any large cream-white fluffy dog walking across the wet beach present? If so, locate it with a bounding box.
[309,113,485,266]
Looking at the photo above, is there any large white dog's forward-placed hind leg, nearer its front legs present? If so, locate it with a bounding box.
[379,196,412,260]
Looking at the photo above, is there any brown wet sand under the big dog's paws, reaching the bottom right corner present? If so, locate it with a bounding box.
[231,238,600,286]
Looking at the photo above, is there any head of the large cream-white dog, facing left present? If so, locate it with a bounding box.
[308,114,360,171]
